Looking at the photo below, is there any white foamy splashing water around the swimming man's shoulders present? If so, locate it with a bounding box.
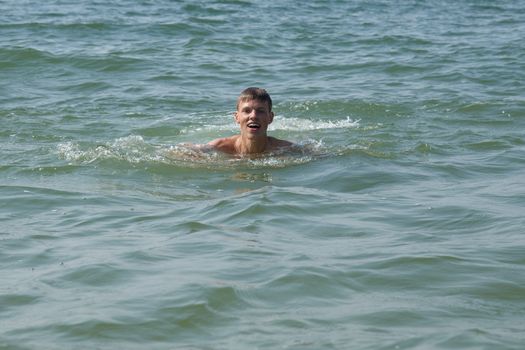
[57,115,359,168]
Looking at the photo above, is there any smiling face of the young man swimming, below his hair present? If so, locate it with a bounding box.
[235,100,274,137]
